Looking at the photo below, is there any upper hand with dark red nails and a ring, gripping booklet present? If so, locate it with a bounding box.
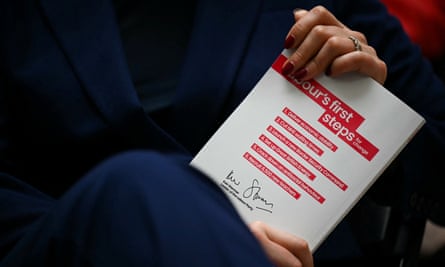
[282,6,387,84]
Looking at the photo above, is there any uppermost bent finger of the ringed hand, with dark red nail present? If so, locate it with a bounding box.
[285,6,347,49]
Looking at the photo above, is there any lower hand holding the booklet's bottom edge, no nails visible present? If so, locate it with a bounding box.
[249,222,314,267]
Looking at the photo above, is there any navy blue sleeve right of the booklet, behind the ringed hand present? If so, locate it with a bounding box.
[333,0,445,224]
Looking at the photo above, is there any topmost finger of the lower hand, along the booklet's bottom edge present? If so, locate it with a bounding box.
[266,223,313,267]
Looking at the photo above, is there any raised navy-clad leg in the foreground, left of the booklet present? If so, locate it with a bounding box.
[0,151,269,267]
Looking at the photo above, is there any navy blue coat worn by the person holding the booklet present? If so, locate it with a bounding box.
[0,0,445,264]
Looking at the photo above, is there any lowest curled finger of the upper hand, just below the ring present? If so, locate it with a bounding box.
[329,51,387,85]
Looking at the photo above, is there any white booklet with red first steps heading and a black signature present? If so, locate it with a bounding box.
[190,50,424,251]
